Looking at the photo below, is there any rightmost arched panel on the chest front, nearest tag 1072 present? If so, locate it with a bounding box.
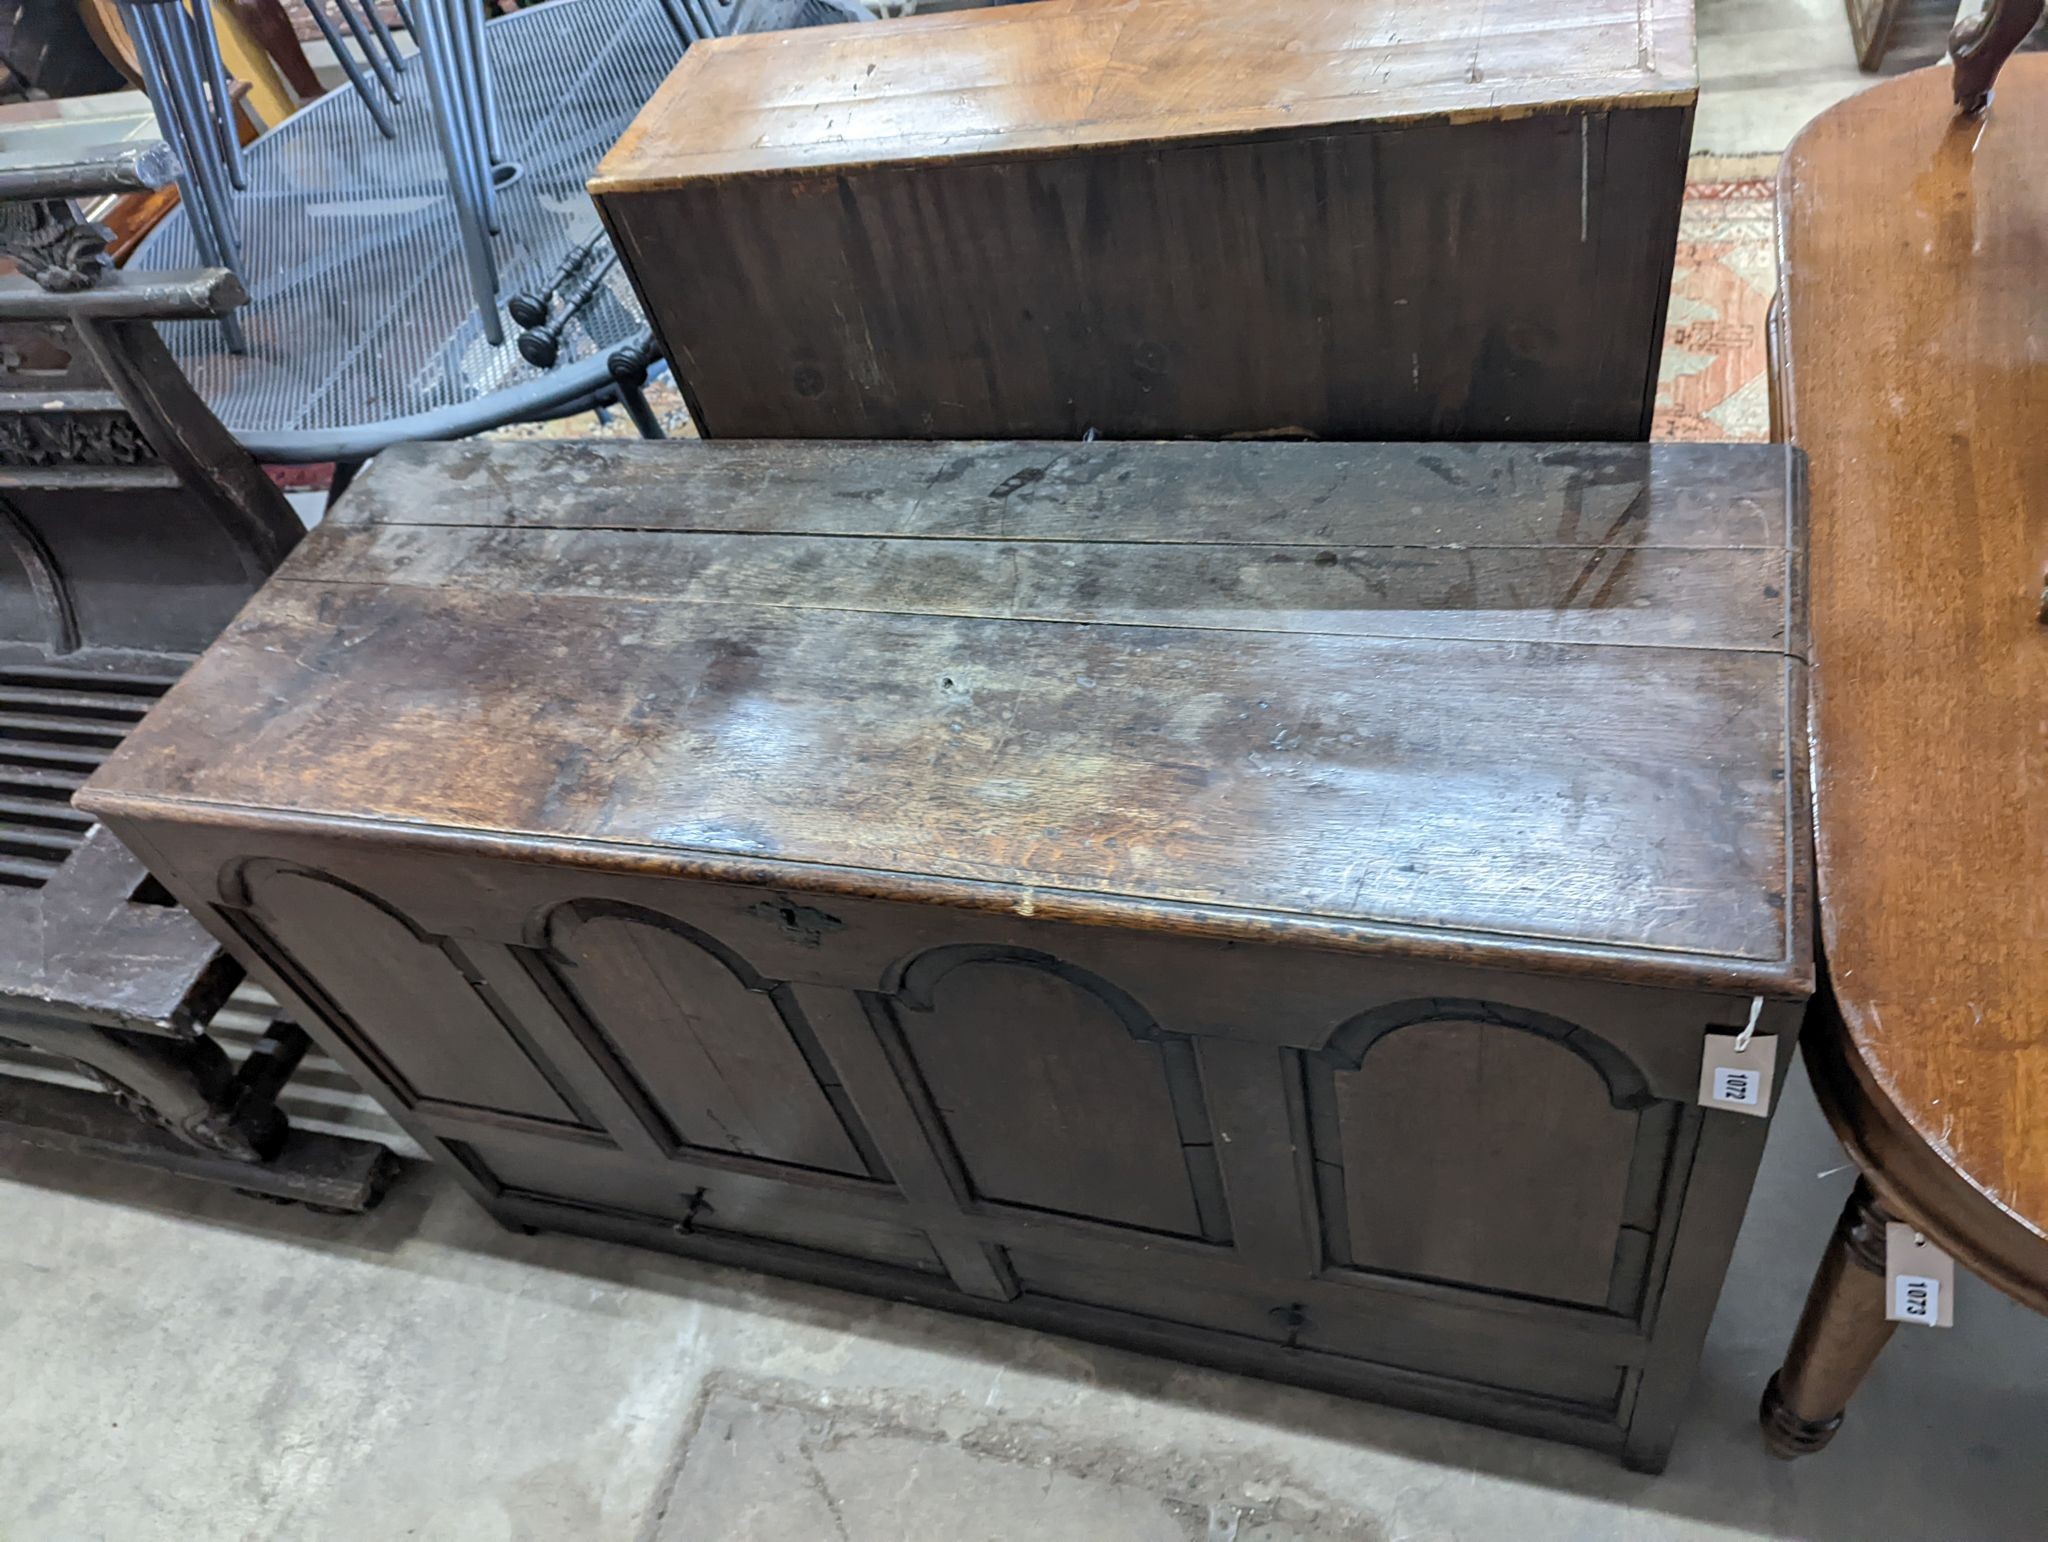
[1309,1001,1671,1309]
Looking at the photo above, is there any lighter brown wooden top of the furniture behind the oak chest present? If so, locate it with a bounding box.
[590,0,1696,185]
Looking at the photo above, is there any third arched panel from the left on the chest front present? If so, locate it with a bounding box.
[893,946,1229,1241]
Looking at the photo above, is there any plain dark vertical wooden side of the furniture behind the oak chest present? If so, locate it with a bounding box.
[598,109,1692,440]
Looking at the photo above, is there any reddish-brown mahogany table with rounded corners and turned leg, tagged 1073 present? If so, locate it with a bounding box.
[1761,55,2048,1456]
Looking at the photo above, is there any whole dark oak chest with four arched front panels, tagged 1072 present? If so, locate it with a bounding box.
[80,442,1810,1466]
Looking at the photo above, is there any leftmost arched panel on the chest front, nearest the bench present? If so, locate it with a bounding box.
[229,864,592,1126]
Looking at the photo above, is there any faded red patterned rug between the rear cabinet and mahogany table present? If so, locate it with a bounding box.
[1651,156,1778,440]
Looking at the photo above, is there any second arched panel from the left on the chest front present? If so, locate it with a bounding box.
[547,901,879,1173]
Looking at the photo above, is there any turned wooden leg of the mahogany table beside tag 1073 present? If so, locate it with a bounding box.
[1757,1177,1894,1458]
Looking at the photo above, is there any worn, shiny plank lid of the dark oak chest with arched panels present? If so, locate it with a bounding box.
[80,440,1810,989]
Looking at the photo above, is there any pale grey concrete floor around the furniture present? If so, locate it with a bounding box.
[0,0,2048,1542]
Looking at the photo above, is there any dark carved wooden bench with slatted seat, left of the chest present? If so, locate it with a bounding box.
[0,145,395,1210]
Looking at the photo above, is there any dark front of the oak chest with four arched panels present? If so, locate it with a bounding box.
[150,831,1777,1429]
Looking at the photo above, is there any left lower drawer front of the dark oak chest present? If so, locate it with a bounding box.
[446,1137,944,1276]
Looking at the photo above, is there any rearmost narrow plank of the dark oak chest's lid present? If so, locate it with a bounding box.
[328,440,1804,549]
